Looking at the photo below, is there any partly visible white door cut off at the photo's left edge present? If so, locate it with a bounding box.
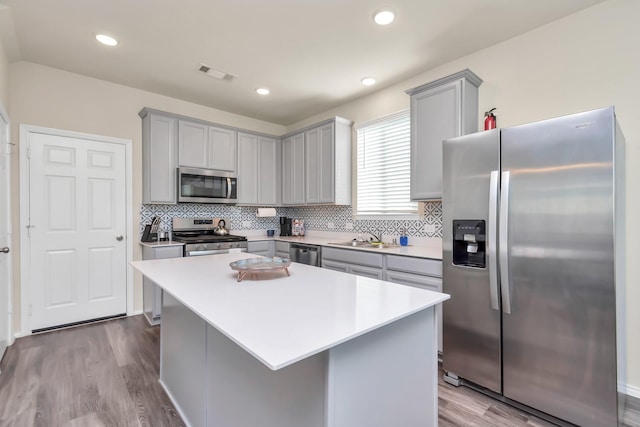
[0,106,13,360]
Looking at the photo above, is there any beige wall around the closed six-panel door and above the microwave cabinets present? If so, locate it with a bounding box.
[6,62,286,331]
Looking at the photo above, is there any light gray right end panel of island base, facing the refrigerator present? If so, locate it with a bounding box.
[327,307,438,427]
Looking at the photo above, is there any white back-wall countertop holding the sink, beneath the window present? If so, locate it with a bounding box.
[242,235,442,260]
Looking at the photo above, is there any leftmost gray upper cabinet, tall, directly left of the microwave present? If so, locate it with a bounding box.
[139,109,178,204]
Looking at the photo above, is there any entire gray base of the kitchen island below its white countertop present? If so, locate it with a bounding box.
[160,292,438,427]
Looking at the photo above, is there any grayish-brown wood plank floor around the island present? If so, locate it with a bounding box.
[0,316,640,427]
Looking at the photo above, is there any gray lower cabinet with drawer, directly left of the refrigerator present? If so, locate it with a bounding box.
[384,255,442,352]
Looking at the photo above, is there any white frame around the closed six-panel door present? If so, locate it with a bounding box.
[20,125,134,336]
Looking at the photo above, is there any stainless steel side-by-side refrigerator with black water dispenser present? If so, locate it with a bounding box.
[442,107,626,426]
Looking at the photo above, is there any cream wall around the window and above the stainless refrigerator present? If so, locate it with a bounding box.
[288,0,640,396]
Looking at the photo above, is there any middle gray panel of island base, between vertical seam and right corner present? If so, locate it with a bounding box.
[207,326,326,427]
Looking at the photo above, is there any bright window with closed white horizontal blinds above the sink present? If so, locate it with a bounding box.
[356,110,418,215]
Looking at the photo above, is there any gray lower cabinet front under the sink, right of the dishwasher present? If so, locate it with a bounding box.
[322,246,384,280]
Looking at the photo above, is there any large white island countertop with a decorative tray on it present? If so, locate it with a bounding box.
[131,253,449,370]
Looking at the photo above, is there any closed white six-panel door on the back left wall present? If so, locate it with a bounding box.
[27,132,127,330]
